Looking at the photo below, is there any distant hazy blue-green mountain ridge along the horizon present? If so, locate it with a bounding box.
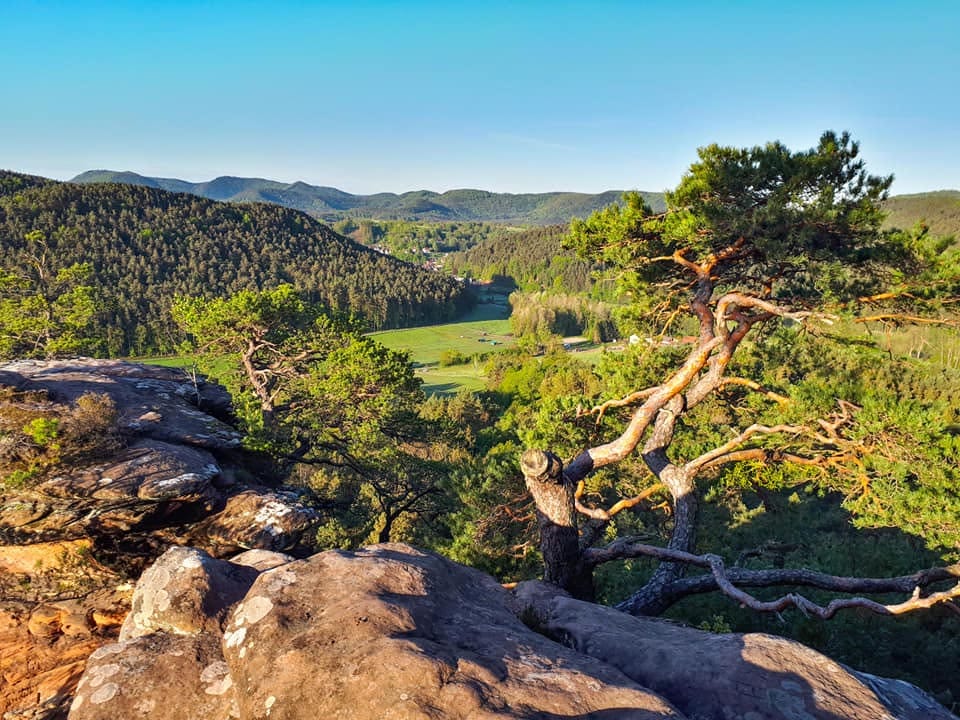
[71,170,665,225]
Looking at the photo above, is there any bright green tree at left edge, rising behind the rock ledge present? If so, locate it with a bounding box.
[0,230,98,359]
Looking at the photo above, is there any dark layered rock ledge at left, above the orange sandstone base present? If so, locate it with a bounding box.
[0,359,315,554]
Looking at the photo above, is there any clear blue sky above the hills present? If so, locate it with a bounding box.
[0,0,960,193]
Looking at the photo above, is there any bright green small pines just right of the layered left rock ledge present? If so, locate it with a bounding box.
[173,285,460,546]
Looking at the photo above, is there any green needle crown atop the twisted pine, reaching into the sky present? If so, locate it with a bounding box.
[568,132,903,318]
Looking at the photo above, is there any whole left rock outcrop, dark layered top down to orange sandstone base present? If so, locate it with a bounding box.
[0,359,315,718]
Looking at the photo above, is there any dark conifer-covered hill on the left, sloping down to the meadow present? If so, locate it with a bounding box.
[0,172,469,354]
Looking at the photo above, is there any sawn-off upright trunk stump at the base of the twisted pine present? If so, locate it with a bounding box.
[520,450,594,600]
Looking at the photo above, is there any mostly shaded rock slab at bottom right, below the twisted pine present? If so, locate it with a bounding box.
[517,582,955,720]
